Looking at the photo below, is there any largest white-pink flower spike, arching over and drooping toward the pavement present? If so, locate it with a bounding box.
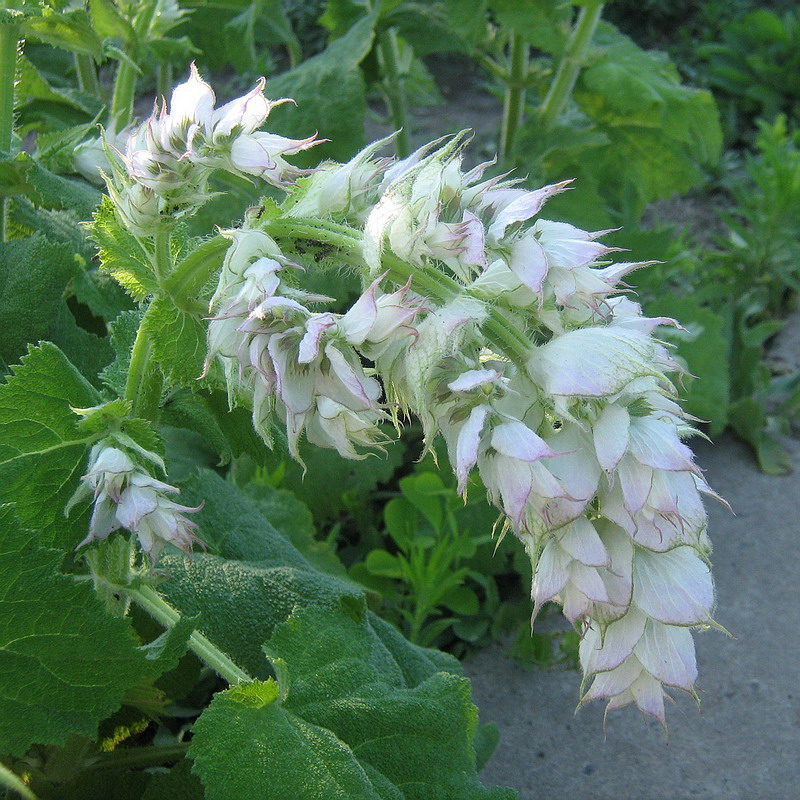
[236,133,714,721]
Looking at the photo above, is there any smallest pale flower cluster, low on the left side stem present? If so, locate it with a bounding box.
[66,440,202,563]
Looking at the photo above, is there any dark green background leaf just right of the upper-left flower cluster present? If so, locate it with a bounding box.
[267,14,374,164]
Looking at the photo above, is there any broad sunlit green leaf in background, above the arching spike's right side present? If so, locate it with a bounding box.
[516,22,722,222]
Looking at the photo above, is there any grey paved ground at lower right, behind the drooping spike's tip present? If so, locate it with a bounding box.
[465,437,800,800]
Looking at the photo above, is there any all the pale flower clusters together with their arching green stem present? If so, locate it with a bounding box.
[76,68,714,722]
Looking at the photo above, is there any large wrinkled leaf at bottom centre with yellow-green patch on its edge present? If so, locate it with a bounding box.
[190,607,514,800]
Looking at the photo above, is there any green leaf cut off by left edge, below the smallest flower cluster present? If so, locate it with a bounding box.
[0,507,151,756]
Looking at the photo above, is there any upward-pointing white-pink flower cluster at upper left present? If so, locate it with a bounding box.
[102,64,318,237]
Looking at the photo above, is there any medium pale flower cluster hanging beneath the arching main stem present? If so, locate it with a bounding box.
[208,229,420,458]
